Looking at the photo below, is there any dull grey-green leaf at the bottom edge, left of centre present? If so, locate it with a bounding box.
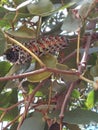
[20,111,45,130]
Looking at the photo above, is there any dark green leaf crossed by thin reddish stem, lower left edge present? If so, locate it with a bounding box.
[0,89,18,121]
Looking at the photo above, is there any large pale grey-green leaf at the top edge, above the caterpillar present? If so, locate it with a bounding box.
[27,0,54,16]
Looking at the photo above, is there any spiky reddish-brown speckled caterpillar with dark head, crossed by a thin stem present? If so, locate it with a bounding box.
[5,36,68,64]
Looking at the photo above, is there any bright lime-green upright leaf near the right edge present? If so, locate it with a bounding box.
[85,90,94,109]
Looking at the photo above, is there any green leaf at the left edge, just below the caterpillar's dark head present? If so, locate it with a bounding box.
[0,61,11,76]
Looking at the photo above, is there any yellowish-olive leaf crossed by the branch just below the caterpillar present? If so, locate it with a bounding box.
[28,54,57,82]
